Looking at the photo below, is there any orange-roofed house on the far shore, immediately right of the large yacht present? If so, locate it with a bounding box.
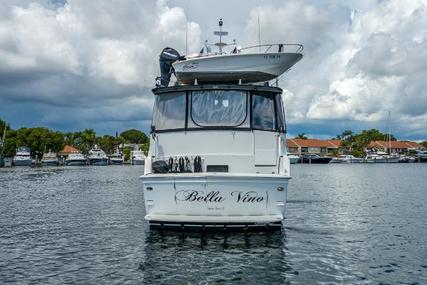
[286,139,341,155]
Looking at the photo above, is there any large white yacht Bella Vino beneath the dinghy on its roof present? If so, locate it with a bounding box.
[141,19,302,227]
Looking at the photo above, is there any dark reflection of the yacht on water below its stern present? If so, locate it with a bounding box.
[140,231,298,284]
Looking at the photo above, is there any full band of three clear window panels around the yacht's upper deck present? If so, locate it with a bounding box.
[152,90,285,132]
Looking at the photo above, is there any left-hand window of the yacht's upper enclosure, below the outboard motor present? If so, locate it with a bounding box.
[153,92,186,130]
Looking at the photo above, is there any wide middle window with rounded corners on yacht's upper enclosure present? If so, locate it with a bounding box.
[191,90,249,127]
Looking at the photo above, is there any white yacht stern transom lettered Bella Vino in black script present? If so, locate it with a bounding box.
[141,173,290,225]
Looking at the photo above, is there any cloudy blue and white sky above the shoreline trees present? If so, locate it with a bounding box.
[0,0,427,140]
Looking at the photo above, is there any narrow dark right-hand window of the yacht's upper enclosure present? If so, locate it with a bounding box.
[252,94,276,131]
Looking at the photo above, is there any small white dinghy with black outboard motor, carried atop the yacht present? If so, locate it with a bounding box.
[157,20,304,87]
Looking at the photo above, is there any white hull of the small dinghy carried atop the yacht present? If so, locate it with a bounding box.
[173,53,302,84]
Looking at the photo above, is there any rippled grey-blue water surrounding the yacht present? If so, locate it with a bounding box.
[0,164,427,284]
